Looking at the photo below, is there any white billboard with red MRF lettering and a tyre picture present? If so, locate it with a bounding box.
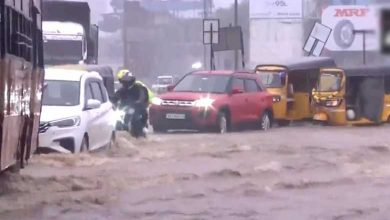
[322,5,379,51]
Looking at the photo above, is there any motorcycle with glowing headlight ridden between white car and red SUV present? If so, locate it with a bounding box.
[115,106,146,138]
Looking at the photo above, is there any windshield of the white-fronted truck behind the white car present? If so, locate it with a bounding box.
[44,40,83,65]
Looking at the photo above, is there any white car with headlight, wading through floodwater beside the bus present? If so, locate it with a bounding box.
[39,68,115,153]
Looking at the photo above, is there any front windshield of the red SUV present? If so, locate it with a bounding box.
[174,74,230,93]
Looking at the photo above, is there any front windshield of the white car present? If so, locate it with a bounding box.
[42,80,80,106]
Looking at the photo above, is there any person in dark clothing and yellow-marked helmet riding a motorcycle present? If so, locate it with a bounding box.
[113,70,149,136]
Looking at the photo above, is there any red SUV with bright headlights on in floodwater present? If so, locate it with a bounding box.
[150,71,273,133]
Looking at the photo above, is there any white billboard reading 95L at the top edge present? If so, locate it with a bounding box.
[249,0,303,19]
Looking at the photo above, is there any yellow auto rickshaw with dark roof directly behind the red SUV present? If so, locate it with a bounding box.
[255,57,336,125]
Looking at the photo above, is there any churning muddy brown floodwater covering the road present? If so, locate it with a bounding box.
[0,126,390,220]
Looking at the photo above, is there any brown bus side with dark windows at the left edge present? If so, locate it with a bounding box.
[0,0,44,171]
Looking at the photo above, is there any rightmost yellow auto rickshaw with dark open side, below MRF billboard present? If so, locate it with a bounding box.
[313,66,390,125]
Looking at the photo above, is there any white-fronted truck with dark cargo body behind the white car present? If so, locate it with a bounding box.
[43,1,99,65]
